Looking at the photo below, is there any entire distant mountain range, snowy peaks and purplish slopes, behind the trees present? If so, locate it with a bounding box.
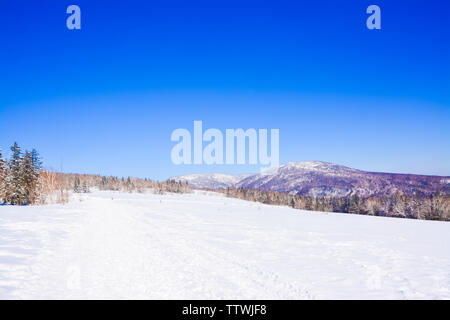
[173,161,450,197]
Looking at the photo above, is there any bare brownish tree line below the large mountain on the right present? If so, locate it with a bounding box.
[221,188,450,221]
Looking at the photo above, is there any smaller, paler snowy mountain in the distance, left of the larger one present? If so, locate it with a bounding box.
[172,173,250,189]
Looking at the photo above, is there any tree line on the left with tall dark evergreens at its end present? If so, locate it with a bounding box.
[0,143,192,205]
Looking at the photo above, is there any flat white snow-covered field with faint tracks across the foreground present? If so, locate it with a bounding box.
[0,191,450,299]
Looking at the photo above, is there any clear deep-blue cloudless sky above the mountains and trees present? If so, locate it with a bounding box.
[0,0,450,179]
